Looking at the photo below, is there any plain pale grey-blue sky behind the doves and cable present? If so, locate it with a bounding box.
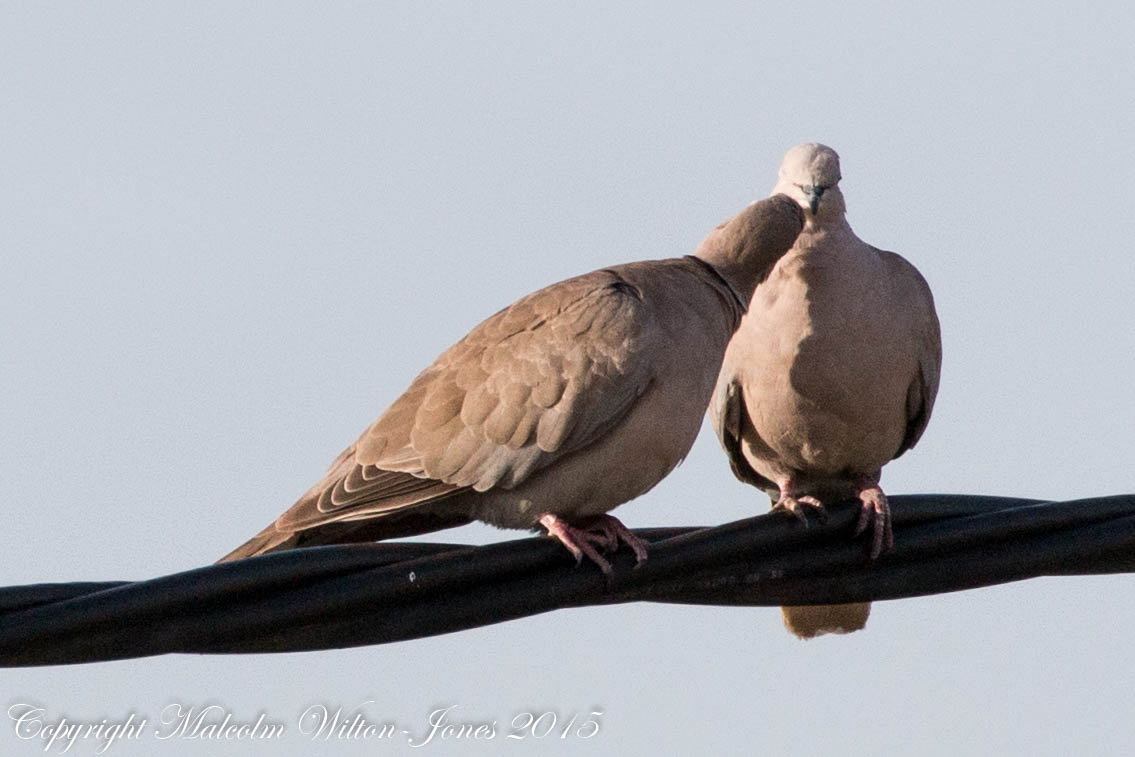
[0,1,1135,756]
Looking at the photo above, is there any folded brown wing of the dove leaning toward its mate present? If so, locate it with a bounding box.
[276,269,659,531]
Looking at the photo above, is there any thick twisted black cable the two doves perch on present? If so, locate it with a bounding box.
[0,495,1135,666]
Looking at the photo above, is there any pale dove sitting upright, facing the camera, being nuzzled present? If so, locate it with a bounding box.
[706,143,942,638]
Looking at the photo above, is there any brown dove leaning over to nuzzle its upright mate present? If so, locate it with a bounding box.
[222,196,804,572]
